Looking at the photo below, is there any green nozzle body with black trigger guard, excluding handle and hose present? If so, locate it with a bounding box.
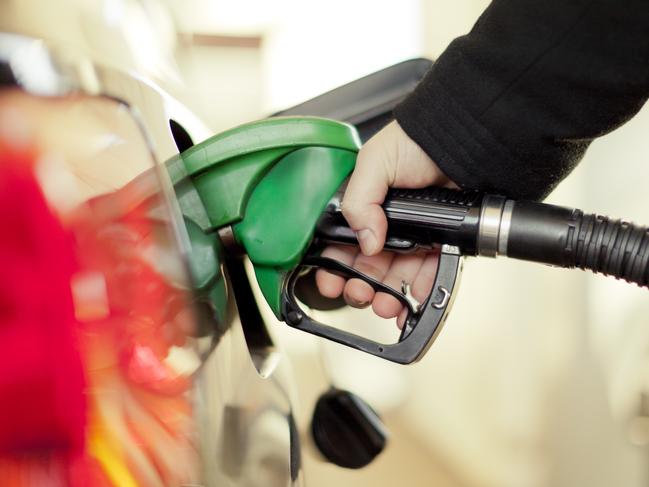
[166,117,461,363]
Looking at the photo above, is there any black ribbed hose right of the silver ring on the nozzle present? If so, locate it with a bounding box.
[506,202,649,288]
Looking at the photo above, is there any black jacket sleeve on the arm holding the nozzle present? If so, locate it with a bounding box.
[394,0,649,199]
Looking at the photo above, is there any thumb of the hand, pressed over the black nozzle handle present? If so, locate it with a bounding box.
[342,141,389,255]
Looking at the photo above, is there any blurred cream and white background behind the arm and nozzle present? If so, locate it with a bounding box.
[5,0,649,487]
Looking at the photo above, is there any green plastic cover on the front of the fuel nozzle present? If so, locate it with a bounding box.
[166,117,360,317]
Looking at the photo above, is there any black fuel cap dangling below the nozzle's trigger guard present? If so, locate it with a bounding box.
[311,389,388,468]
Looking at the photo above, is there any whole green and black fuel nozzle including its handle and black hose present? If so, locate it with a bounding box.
[166,117,649,364]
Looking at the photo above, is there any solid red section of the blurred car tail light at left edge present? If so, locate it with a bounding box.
[0,141,86,453]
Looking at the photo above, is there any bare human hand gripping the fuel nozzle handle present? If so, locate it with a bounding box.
[316,121,457,327]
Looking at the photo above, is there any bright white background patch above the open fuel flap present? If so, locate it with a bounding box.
[263,0,423,111]
